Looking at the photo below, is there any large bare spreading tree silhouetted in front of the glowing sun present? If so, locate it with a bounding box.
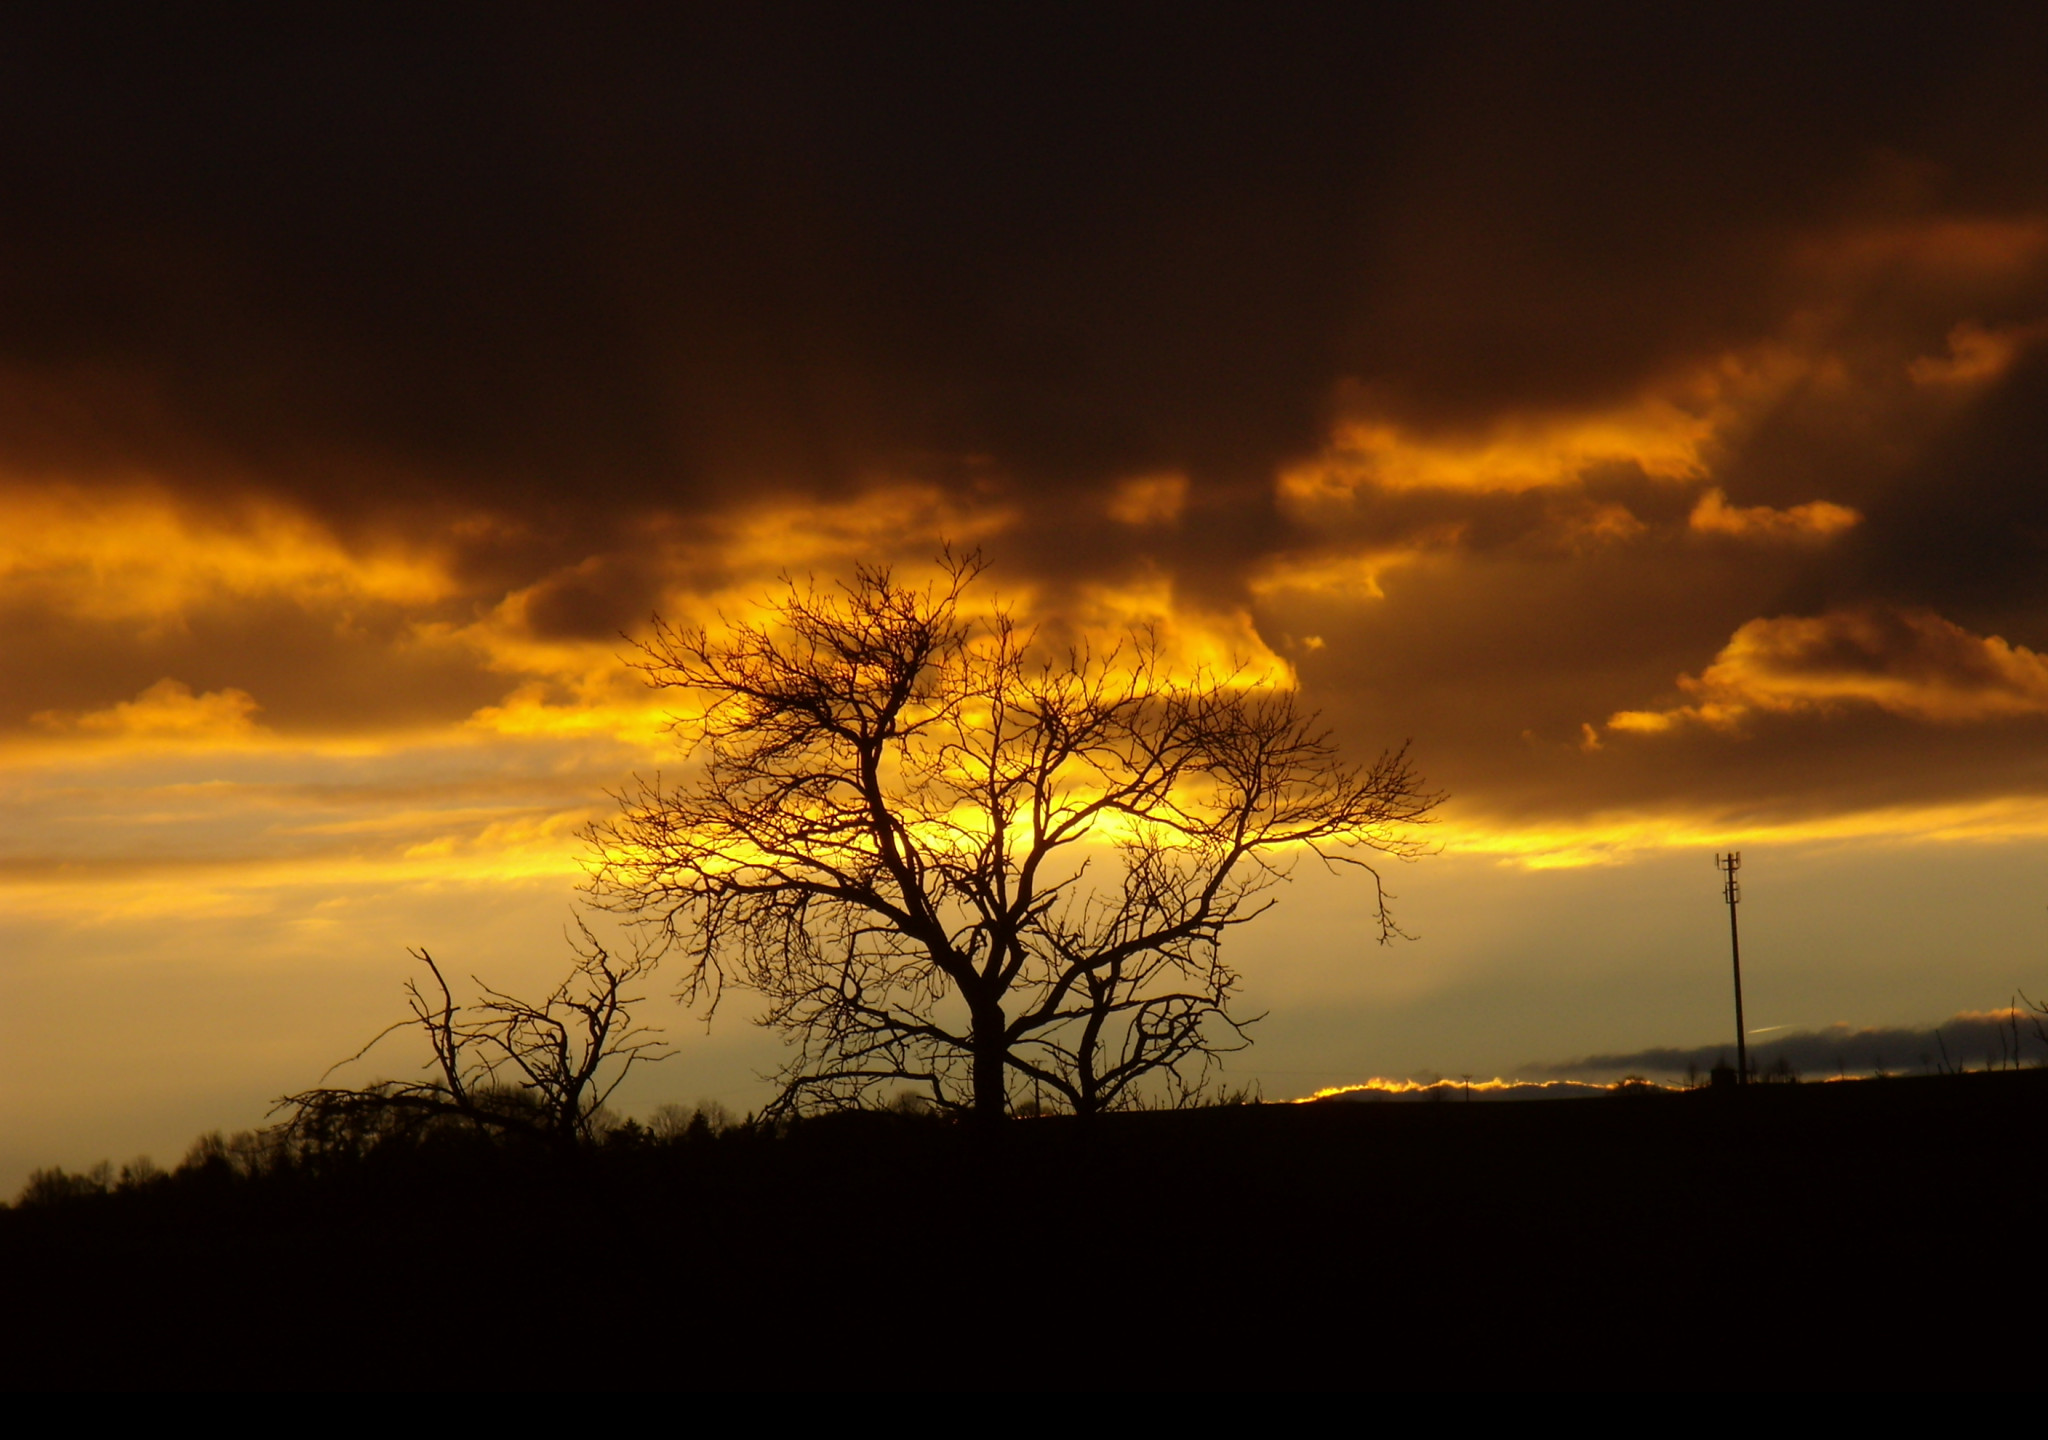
[590,555,1440,1118]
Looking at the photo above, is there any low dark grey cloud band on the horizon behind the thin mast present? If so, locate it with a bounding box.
[1522,1010,2048,1077]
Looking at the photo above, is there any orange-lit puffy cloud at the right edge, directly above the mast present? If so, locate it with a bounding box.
[1608,606,2048,733]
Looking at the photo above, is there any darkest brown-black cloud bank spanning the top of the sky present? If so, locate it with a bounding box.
[0,6,2032,514]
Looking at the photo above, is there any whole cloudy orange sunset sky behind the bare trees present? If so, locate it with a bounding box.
[0,4,2048,1192]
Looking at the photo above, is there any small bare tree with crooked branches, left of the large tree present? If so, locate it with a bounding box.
[279,922,668,1145]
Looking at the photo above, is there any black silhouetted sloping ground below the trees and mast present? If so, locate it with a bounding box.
[0,1071,2048,1391]
